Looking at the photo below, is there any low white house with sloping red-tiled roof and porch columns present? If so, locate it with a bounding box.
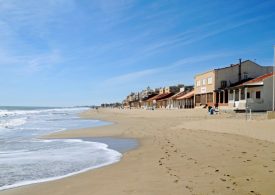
[228,72,274,111]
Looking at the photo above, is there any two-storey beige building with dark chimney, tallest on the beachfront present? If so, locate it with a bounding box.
[194,60,273,106]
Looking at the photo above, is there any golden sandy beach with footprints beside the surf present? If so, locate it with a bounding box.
[0,109,275,195]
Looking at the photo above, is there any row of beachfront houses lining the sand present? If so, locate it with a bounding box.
[122,59,274,111]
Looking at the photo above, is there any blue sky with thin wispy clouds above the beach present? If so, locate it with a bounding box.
[0,0,275,106]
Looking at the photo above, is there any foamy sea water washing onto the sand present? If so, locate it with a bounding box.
[0,107,122,190]
